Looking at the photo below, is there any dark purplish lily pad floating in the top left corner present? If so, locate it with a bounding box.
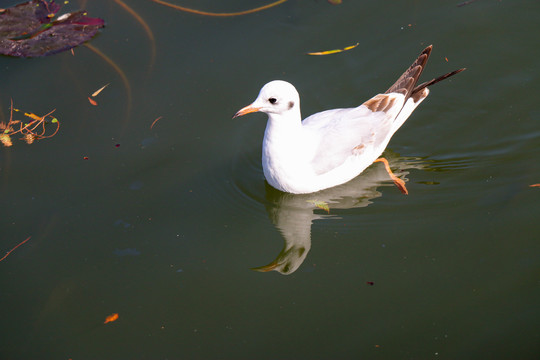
[0,0,105,57]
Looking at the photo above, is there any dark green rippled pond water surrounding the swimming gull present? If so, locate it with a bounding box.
[0,0,540,360]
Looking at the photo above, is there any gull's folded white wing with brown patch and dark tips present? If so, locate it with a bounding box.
[303,45,465,175]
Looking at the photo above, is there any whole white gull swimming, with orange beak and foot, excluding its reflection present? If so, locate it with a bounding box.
[233,45,465,194]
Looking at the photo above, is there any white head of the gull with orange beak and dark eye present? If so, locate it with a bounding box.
[233,80,300,119]
